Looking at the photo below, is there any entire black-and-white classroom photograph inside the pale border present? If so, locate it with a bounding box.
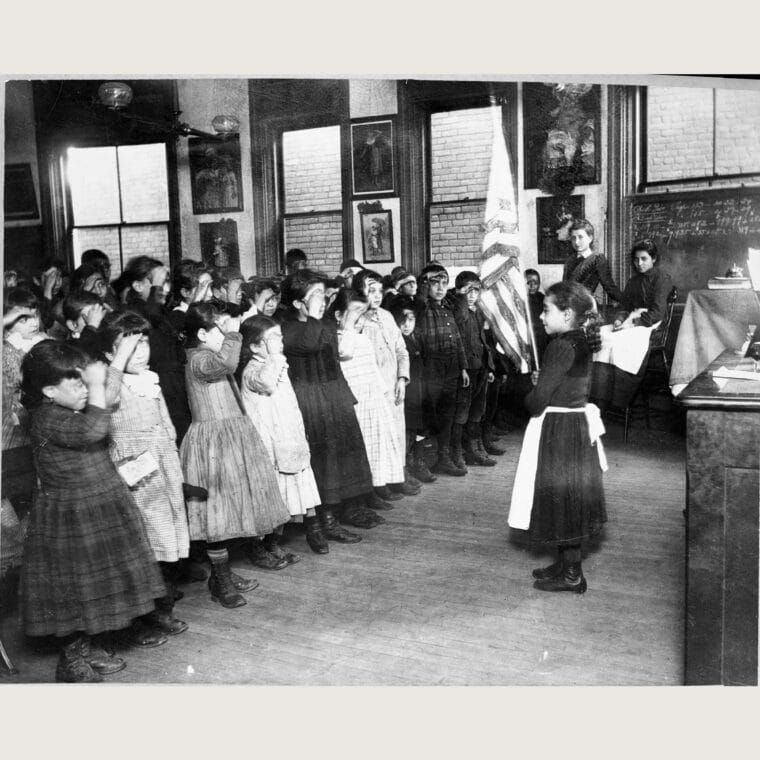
[0,70,760,712]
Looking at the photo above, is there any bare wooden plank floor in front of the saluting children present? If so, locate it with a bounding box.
[0,412,685,686]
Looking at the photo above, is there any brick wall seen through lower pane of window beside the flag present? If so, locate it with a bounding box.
[430,203,485,266]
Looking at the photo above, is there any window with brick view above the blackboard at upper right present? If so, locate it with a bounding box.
[639,87,760,190]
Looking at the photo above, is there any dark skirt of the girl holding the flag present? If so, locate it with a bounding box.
[528,412,607,546]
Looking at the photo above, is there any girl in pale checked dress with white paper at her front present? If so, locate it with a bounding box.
[101,312,190,635]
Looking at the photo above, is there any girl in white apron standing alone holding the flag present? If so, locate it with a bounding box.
[509,282,607,594]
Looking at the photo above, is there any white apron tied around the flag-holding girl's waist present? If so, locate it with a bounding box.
[507,404,608,530]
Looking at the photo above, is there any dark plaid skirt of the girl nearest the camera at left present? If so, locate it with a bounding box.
[21,478,166,636]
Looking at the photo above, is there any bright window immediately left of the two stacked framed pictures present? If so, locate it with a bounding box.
[281,125,343,272]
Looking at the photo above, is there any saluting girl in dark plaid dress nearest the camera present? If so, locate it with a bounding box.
[21,340,166,681]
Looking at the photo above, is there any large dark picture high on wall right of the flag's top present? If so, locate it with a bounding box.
[523,82,602,190]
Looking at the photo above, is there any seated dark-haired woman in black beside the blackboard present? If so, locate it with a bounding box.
[613,240,673,330]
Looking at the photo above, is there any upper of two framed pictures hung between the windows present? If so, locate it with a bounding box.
[351,118,396,195]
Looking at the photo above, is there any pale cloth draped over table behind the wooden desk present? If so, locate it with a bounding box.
[670,289,760,393]
